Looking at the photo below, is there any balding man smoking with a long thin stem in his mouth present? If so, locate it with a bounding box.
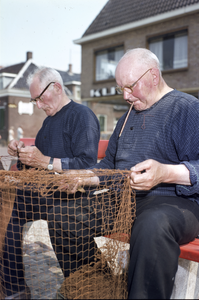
[49,48,199,299]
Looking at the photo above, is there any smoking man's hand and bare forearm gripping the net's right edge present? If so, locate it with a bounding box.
[130,159,191,191]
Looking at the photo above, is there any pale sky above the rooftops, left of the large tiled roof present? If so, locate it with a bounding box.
[0,0,108,73]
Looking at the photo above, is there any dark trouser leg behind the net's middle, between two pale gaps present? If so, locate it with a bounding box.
[48,195,117,277]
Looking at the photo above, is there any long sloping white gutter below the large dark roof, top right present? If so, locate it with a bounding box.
[73,3,199,45]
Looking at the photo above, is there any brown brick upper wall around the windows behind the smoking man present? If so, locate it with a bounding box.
[81,13,199,100]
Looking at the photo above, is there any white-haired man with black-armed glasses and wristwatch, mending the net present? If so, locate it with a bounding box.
[3,68,100,299]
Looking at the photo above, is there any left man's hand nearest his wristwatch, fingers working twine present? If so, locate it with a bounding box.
[18,146,47,168]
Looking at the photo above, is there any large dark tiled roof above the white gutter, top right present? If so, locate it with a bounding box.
[83,0,199,37]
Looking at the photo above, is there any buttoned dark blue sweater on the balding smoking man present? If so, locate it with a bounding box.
[93,90,199,203]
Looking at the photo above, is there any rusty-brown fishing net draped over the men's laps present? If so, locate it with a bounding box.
[0,159,136,299]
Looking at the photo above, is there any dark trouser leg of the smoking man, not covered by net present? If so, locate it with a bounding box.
[128,196,199,299]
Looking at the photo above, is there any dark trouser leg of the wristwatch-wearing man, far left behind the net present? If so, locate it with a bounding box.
[2,190,59,296]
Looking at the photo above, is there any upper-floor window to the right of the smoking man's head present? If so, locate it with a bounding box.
[148,30,188,71]
